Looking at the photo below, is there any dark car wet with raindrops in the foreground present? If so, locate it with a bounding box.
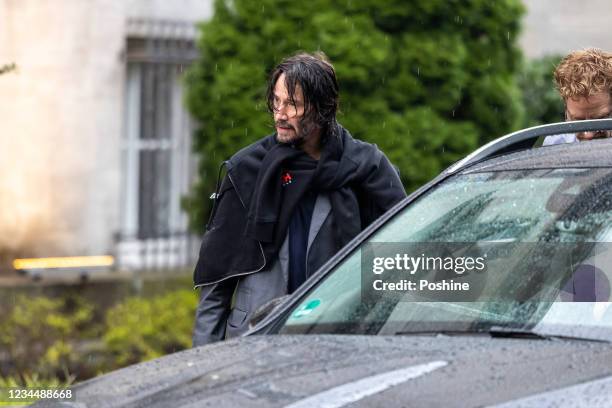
[35,120,612,408]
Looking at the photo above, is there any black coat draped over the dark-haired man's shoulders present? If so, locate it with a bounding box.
[194,127,406,286]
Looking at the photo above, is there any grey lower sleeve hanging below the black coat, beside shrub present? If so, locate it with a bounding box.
[193,278,238,347]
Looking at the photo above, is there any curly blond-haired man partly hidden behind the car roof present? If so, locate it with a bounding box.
[544,48,612,146]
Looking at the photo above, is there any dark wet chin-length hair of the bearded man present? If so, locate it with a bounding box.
[266,51,339,133]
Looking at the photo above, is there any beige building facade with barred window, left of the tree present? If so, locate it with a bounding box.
[0,0,212,268]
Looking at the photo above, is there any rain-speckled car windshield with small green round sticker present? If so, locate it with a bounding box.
[279,168,612,341]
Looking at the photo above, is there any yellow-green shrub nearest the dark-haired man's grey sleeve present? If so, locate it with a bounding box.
[103,290,197,366]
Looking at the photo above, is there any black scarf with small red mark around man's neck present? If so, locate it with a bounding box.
[245,128,361,260]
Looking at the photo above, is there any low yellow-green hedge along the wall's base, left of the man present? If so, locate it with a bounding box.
[0,290,197,386]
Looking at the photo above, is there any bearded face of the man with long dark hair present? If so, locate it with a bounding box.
[273,74,314,145]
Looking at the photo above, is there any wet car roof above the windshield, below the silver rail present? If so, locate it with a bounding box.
[461,139,612,174]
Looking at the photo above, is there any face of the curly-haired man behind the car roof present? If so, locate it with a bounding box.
[565,92,612,141]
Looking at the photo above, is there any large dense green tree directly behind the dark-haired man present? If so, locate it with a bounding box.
[184,0,523,230]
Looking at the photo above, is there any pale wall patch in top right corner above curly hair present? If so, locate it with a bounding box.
[520,0,612,58]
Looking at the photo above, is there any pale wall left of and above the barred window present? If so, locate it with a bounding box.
[0,0,211,256]
